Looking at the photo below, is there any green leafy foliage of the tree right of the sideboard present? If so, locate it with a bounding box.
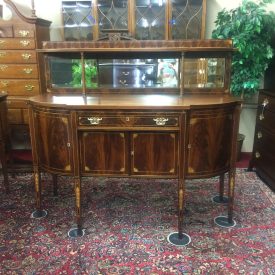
[212,0,275,97]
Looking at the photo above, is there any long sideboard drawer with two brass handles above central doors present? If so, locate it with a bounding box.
[79,112,179,127]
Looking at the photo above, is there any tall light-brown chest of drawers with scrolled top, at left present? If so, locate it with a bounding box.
[0,0,51,165]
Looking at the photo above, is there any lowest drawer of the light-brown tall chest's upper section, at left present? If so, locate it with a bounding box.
[0,79,39,96]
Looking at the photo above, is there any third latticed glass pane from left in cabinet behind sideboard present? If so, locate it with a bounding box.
[136,0,166,40]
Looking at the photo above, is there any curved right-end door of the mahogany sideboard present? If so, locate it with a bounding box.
[186,107,234,178]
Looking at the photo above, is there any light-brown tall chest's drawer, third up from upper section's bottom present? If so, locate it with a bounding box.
[0,50,37,64]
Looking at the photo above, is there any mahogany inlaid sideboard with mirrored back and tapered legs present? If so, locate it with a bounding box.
[28,40,241,245]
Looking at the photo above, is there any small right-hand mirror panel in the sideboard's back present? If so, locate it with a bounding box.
[183,58,225,88]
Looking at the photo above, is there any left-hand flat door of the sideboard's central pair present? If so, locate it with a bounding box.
[80,131,128,175]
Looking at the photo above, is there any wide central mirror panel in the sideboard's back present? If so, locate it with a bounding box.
[98,59,179,88]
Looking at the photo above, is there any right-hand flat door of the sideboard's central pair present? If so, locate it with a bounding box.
[131,132,178,177]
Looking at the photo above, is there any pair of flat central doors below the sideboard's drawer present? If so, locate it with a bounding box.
[79,130,178,177]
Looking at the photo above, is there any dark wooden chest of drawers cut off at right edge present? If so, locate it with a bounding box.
[250,90,275,190]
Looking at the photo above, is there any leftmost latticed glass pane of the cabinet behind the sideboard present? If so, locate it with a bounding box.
[62,1,95,41]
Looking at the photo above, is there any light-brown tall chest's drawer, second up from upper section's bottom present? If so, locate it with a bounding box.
[0,64,38,79]
